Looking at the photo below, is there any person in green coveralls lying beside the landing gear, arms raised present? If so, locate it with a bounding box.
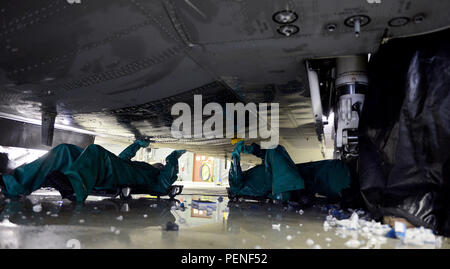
[228,141,351,202]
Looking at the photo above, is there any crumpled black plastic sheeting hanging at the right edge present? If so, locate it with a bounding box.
[359,30,450,235]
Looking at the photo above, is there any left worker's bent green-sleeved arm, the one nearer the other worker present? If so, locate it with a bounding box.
[153,150,186,193]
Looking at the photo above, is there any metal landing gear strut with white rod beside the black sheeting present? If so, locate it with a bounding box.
[306,55,368,160]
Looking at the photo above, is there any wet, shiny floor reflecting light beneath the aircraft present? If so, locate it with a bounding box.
[0,191,450,249]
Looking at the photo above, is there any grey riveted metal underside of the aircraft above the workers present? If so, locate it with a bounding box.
[0,0,450,161]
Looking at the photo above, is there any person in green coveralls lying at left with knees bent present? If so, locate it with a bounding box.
[0,140,186,202]
